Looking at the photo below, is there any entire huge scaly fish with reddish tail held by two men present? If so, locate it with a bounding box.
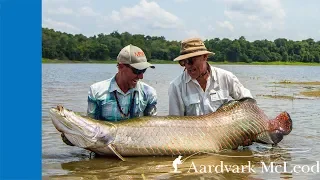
[50,99,292,156]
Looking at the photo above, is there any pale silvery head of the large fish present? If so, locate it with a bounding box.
[50,106,116,148]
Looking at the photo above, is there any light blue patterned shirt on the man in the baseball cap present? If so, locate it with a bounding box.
[87,76,157,121]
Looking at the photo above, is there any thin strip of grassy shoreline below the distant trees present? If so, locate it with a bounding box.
[41,58,320,66]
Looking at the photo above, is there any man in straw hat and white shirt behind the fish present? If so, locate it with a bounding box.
[168,38,252,116]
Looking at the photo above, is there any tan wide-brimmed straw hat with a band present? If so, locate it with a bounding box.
[173,38,215,61]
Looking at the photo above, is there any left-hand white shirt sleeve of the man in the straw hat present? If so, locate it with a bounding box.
[168,83,185,116]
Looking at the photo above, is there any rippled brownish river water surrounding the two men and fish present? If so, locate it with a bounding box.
[42,64,320,179]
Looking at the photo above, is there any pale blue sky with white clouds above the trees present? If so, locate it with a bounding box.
[42,0,320,41]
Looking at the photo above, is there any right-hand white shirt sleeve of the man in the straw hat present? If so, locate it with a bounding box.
[229,74,252,100]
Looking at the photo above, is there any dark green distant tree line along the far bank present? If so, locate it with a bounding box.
[42,28,320,63]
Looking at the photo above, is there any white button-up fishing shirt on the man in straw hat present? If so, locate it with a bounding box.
[168,66,252,116]
